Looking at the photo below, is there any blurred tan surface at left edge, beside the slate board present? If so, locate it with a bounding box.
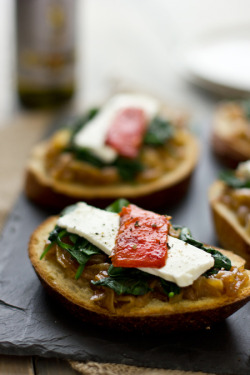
[0,112,54,231]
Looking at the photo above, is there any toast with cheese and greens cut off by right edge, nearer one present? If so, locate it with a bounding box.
[209,160,250,268]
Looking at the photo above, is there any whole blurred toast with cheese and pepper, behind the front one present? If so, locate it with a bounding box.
[25,94,198,207]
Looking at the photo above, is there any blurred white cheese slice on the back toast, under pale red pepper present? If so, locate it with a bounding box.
[73,94,159,163]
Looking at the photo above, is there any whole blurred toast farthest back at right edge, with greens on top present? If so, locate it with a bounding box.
[212,101,250,168]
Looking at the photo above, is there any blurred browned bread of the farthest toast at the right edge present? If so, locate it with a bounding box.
[212,102,250,168]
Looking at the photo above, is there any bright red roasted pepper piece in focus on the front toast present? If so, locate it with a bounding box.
[111,204,169,268]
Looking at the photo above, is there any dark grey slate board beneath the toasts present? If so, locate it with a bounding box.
[0,97,250,375]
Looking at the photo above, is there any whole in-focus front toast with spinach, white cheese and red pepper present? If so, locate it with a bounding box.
[29,200,250,333]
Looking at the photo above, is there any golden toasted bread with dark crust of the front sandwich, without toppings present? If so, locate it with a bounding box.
[29,217,250,333]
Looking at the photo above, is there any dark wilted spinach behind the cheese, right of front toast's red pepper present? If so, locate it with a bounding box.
[174,226,232,276]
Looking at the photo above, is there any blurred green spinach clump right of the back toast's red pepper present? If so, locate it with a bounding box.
[144,117,174,146]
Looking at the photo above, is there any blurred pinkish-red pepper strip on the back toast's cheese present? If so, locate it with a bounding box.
[106,108,146,159]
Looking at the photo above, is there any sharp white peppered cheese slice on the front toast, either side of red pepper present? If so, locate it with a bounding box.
[57,202,214,287]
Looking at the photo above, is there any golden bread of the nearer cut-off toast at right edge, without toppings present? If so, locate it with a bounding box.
[209,180,250,268]
